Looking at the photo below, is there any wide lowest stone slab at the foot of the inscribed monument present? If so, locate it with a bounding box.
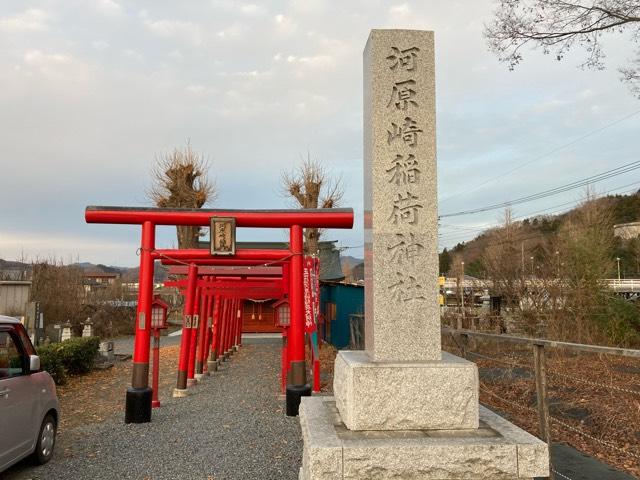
[300,397,549,480]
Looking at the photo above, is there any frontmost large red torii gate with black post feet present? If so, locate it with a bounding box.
[85,206,353,423]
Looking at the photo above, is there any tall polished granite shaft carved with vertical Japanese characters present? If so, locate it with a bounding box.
[364,30,440,361]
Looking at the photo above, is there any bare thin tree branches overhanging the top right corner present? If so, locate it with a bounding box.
[484,0,640,98]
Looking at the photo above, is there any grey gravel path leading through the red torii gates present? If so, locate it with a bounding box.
[0,344,302,480]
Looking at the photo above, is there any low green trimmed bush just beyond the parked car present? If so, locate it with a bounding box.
[38,337,100,385]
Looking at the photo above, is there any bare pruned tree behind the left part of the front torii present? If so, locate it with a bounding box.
[148,143,216,248]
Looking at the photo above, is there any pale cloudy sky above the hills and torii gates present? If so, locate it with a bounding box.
[0,0,640,266]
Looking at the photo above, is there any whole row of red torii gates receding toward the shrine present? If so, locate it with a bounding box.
[85,206,353,423]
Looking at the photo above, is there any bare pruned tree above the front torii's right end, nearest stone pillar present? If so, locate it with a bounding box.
[282,155,344,254]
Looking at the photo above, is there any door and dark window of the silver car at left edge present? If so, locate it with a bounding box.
[0,326,38,469]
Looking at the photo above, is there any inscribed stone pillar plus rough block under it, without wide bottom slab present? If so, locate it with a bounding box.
[334,30,479,430]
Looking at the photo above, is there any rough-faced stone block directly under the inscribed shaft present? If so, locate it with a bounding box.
[333,351,478,430]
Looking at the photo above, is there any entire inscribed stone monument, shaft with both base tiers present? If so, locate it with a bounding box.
[300,30,549,480]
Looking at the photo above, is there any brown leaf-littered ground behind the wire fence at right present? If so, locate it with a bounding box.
[444,336,640,476]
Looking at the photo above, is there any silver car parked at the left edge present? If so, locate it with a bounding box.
[0,315,59,472]
